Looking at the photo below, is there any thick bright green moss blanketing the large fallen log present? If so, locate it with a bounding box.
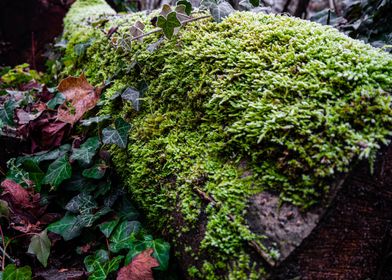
[64,0,392,279]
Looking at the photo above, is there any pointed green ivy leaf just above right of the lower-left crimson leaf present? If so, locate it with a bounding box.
[42,155,72,187]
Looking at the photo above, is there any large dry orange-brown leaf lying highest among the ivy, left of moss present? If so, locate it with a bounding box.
[57,74,102,124]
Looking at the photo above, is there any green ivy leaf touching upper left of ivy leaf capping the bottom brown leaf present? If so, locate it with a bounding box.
[110,221,140,253]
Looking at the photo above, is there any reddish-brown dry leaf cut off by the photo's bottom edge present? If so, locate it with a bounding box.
[117,248,159,280]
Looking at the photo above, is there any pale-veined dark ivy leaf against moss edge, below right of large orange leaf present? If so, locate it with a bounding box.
[102,118,131,148]
